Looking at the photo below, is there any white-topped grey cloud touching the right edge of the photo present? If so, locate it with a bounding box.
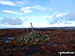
[56,11,75,21]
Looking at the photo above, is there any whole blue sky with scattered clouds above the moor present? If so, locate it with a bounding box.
[0,0,75,28]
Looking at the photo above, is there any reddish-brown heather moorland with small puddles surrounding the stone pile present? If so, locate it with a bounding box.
[0,28,75,56]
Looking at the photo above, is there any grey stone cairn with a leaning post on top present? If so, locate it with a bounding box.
[16,23,48,44]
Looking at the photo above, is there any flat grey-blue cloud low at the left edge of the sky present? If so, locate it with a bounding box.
[0,17,23,25]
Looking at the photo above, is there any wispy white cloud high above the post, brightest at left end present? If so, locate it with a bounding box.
[21,5,52,13]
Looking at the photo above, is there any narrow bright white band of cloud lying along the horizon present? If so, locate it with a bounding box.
[0,22,75,29]
